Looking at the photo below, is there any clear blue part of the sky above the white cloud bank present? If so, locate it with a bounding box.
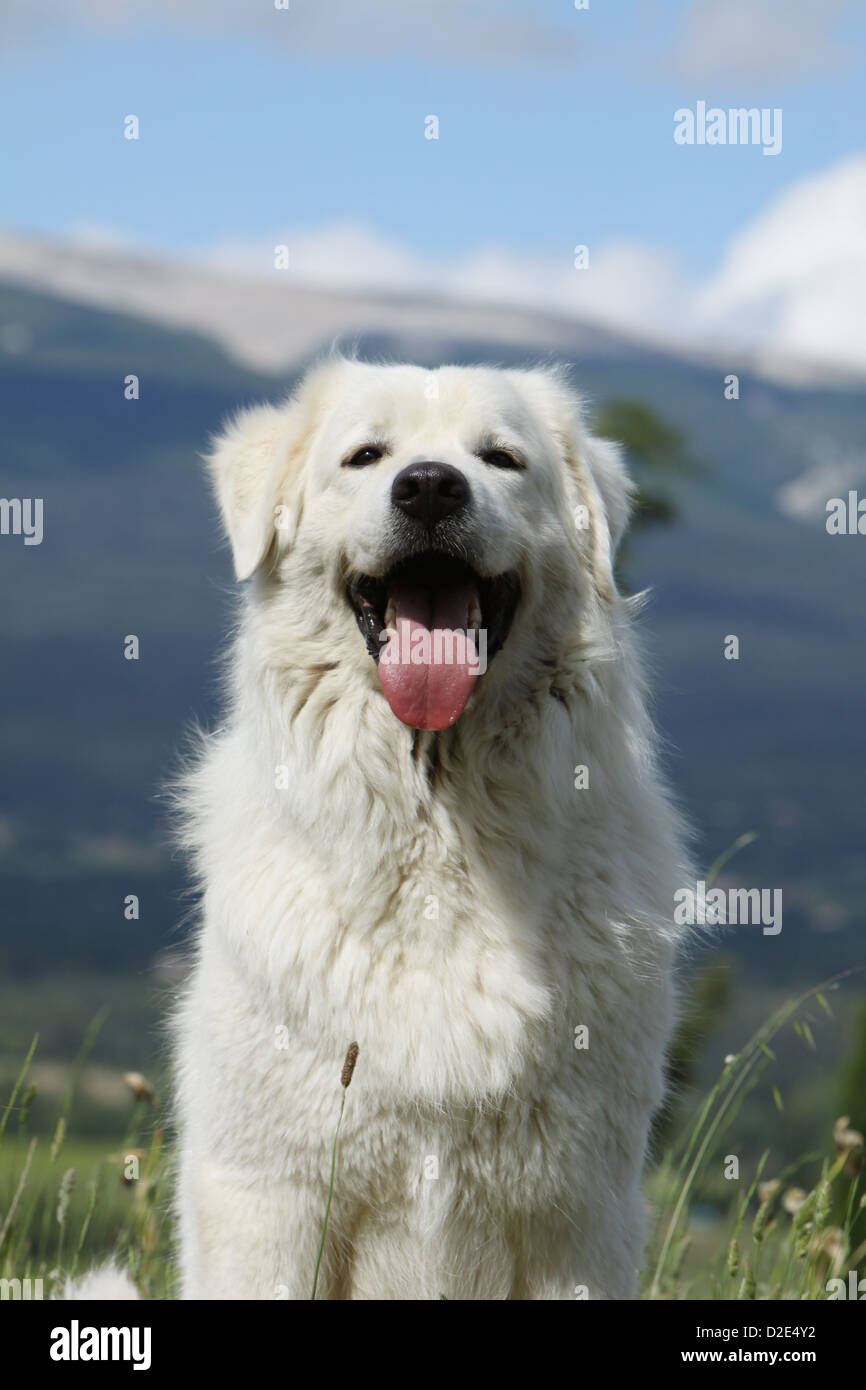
[0,0,866,271]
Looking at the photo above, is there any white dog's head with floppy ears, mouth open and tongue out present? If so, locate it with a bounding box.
[210,359,630,730]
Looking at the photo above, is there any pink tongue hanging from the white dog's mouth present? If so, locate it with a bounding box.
[379,584,478,728]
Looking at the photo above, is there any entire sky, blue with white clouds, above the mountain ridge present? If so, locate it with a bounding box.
[0,0,866,364]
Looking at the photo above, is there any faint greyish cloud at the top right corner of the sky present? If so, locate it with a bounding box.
[673,0,853,82]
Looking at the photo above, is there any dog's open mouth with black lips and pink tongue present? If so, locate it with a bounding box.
[346,550,520,728]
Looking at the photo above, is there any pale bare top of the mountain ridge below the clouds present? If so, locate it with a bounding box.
[0,232,865,389]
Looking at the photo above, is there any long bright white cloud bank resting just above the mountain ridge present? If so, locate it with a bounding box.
[194,156,866,371]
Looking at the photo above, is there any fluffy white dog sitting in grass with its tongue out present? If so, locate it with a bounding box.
[177,360,685,1300]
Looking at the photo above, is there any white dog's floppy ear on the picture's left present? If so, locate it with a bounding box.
[207,406,307,580]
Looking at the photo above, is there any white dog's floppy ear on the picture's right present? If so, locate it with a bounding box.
[517,368,634,595]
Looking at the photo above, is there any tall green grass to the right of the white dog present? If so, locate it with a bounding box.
[642,970,866,1300]
